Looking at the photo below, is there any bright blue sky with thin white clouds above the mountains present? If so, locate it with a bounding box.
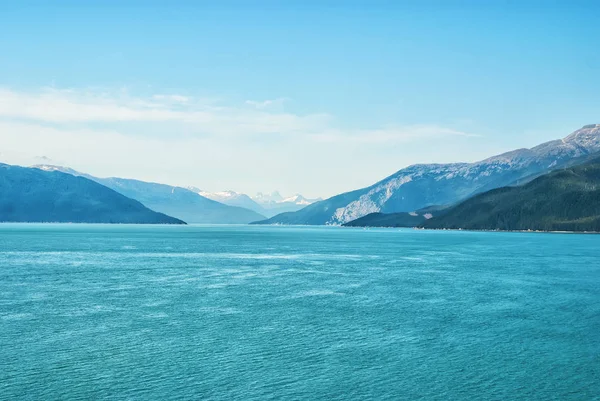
[0,0,600,197]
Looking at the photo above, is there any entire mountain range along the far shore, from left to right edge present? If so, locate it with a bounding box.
[0,124,600,230]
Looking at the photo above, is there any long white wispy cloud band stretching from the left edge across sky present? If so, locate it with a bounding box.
[0,88,473,144]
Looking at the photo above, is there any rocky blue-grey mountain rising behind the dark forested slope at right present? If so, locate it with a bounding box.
[256,124,600,225]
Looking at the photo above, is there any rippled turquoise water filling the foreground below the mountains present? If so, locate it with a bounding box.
[0,225,600,400]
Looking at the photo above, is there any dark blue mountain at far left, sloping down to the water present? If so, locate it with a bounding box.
[0,164,185,224]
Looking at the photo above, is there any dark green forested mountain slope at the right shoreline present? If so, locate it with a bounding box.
[423,158,600,231]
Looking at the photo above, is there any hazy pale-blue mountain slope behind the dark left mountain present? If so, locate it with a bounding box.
[35,165,264,224]
